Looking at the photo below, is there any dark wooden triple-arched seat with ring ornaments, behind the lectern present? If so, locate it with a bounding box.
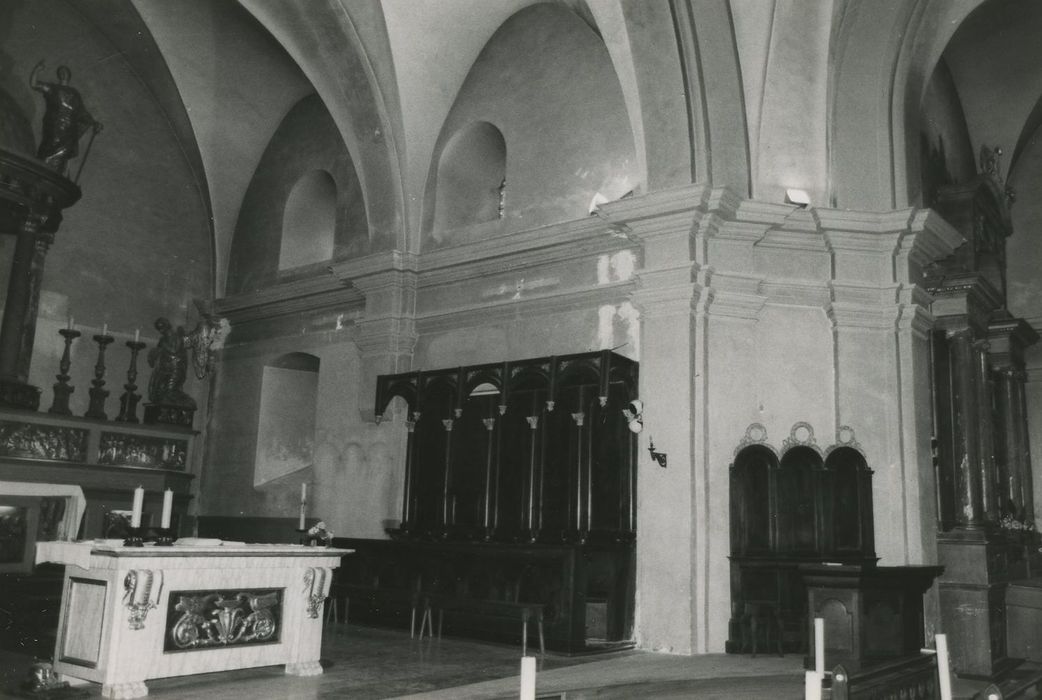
[727,441,876,652]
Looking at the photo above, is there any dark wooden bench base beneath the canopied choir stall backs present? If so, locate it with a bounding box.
[331,538,634,653]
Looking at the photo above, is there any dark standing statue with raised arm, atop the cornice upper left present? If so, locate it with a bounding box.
[29,60,102,175]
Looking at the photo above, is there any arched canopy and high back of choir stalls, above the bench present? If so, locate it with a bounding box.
[376,351,637,543]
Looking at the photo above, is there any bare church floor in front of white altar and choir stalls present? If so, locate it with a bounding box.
[0,625,803,700]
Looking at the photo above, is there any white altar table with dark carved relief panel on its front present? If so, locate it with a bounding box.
[36,542,351,698]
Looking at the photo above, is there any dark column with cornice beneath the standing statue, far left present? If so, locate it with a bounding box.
[0,151,80,410]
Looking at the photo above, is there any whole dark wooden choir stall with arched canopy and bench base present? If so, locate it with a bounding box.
[332,351,638,653]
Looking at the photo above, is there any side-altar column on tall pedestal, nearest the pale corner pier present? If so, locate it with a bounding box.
[931,273,1011,678]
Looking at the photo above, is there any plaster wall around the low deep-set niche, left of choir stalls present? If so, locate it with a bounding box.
[201,330,404,538]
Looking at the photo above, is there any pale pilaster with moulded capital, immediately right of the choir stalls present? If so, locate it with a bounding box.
[602,188,705,654]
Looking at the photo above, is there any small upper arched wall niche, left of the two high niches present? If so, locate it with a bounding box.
[278,170,337,271]
